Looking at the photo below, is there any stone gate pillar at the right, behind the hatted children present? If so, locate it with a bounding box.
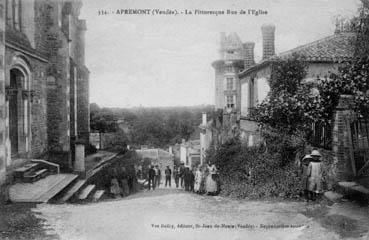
[332,95,354,181]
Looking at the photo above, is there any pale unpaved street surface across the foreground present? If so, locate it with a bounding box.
[33,188,369,240]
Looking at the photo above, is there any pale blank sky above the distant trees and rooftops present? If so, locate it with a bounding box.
[80,0,359,107]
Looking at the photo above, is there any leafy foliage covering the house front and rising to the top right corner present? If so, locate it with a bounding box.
[252,0,369,134]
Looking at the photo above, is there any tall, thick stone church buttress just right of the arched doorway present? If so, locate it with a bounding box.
[45,1,74,172]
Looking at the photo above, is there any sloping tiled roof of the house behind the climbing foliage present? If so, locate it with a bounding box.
[278,32,355,62]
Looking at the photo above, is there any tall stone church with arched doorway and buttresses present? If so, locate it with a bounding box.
[0,0,90,185]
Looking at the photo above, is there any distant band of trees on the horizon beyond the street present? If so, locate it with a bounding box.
[90,104,212,147]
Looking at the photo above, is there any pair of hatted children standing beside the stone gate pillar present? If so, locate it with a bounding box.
[300,150,323,201]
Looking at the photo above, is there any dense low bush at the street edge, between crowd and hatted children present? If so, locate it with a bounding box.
[209,139,302,199]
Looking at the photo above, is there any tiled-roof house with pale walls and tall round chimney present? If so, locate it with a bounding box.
[238,25,355,145]
